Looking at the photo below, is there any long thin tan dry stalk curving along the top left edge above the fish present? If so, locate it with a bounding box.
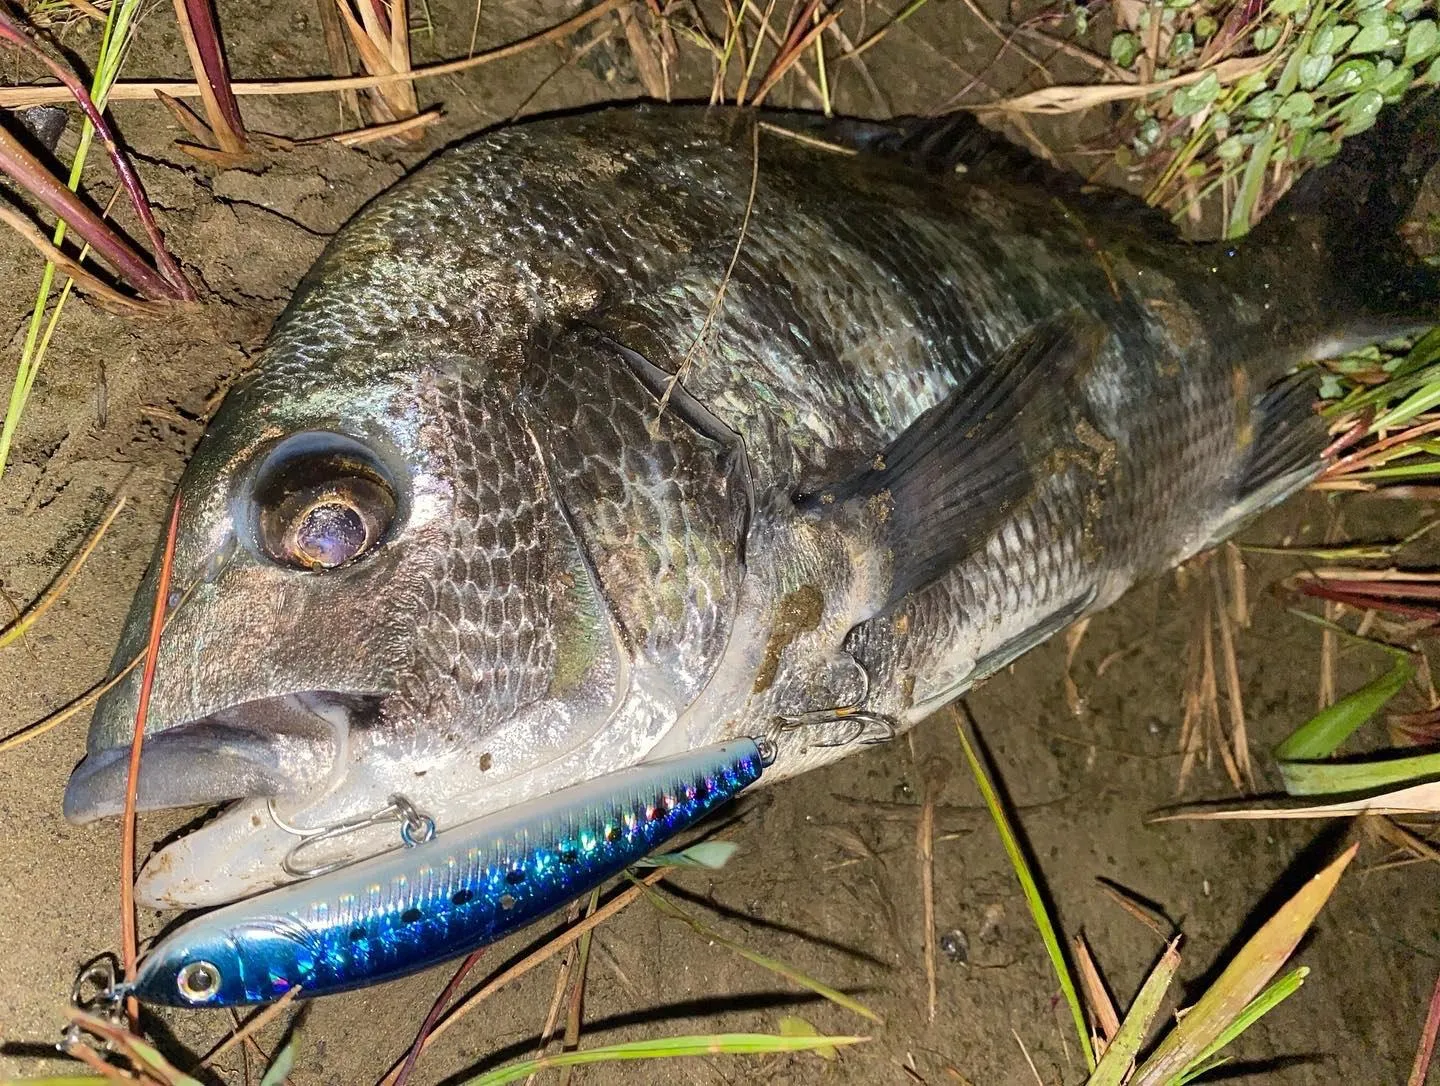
[0,0,631,109]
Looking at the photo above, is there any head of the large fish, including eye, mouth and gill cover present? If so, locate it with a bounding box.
[65,221,749,907]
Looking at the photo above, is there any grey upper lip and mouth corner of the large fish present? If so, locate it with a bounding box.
[63,690,368,825]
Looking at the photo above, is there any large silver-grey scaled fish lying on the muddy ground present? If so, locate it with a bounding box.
[65,105,1440,907]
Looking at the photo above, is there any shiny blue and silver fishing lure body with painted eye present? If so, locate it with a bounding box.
[122,739,769,1007]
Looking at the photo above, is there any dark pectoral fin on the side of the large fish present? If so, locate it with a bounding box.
[796,314,1106,614]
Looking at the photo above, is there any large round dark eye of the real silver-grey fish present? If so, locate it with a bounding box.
[253,435,396,570]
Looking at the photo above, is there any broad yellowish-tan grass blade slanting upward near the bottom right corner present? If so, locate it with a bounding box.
[1130,844,1359,1086]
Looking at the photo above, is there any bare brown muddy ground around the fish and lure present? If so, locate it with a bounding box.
[0,0,1440,1086]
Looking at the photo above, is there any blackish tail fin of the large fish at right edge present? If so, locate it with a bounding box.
[1253,91,1440,337]
